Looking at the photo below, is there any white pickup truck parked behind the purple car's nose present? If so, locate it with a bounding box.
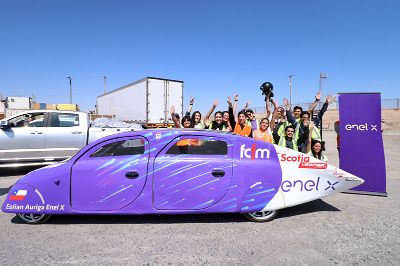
[0,110,141,168]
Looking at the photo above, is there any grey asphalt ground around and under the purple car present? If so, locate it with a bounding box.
[0,132,400,265]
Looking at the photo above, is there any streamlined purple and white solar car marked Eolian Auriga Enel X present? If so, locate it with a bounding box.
[2,129,364,223]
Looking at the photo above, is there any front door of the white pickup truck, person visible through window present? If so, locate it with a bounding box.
[0,112,46,163]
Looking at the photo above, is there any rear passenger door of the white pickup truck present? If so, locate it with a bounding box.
[46,112,86,160]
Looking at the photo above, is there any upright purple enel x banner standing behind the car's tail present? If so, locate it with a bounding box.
[339,93,386,195]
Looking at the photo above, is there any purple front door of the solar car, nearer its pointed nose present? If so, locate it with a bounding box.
[71,137,149,211]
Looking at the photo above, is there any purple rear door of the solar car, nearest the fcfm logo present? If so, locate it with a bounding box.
[153,136,233,210]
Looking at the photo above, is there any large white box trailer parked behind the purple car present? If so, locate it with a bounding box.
[96,77,183,125]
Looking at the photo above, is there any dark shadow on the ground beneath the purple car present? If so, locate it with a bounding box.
[11,199,340,225]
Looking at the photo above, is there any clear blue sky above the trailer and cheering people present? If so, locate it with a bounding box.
[0,0,400,112]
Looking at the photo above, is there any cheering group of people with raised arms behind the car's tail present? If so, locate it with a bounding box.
[170,92,332,161]
